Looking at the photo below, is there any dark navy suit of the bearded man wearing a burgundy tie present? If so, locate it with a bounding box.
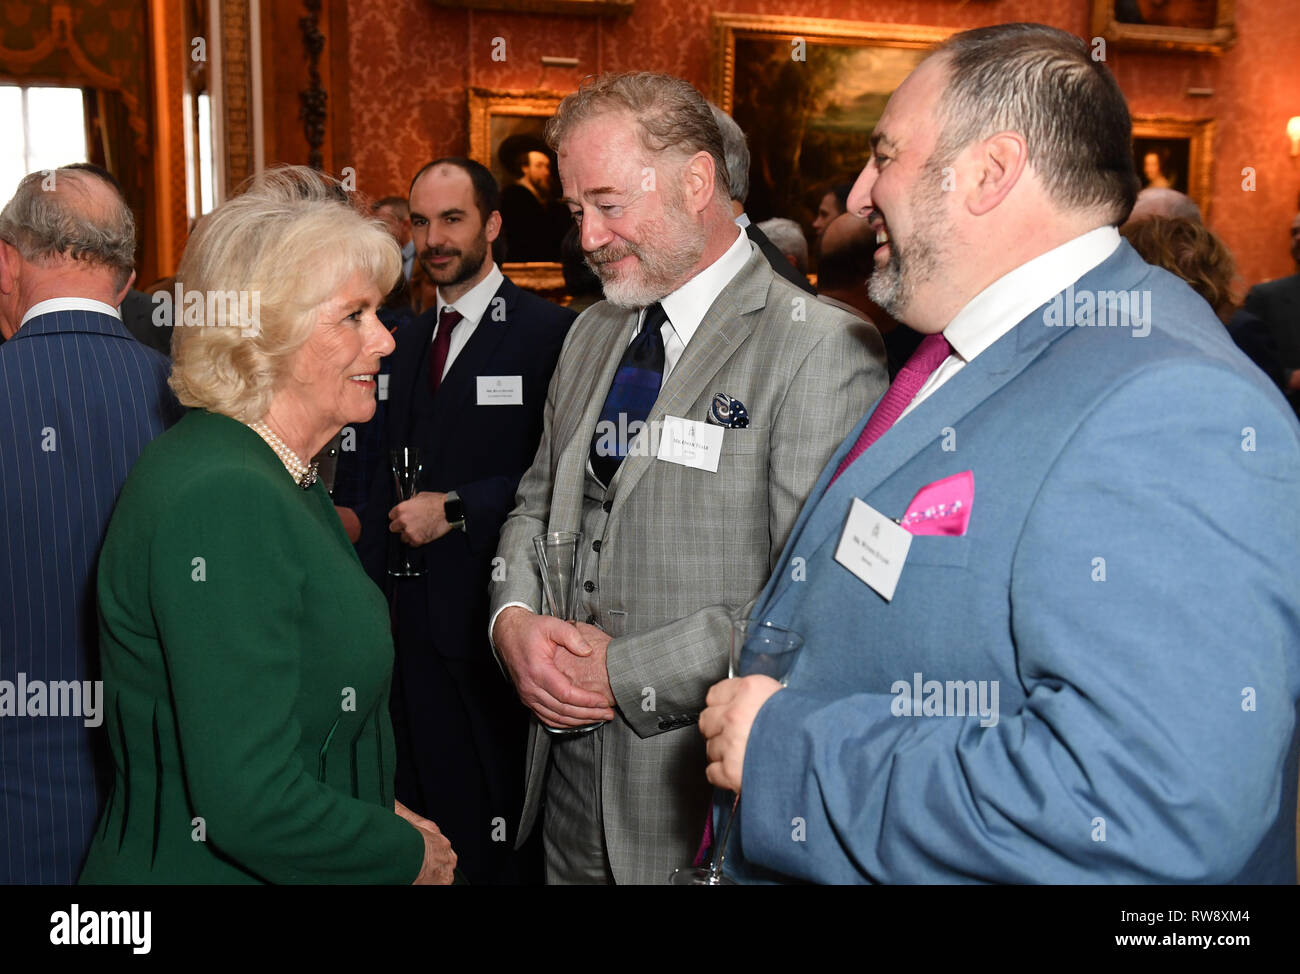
[359,271,576,853]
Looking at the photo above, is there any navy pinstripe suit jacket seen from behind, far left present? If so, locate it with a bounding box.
[0,311,178,883]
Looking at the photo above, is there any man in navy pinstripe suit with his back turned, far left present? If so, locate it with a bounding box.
[0,165,178,884]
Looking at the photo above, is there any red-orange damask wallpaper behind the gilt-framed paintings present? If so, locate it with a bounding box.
[348,0,1300,285]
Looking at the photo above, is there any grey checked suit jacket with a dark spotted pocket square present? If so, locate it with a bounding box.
[493,248,888,883]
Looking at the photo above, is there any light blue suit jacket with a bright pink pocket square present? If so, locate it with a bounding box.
[715,243,1300,883]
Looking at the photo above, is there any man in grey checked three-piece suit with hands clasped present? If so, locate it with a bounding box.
[491,74,887,883]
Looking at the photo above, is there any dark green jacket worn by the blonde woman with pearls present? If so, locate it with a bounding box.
[81,411,424,883]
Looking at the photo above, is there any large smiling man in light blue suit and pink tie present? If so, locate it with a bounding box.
[699,25,1300,883]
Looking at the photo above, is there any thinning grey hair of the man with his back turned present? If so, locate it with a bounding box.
[0,166,135,290]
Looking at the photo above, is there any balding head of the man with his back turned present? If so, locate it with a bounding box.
[0,165,135,336]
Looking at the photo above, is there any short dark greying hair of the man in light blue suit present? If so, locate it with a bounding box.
[932,23,1138,225]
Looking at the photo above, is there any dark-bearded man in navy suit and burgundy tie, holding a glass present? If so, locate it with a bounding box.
[361,159,576,883]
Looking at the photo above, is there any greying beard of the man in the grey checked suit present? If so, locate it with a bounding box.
[586,204,705,308]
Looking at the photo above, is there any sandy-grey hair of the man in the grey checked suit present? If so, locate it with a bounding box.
[545,72,732,203]
